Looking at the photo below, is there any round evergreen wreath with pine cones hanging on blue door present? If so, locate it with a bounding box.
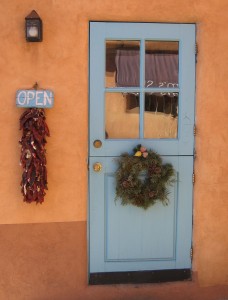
[115,145,175,209]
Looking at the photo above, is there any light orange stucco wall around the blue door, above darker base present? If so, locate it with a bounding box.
[0,0,228,286]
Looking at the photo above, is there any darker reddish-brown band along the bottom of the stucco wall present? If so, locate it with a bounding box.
[0,222,228,300]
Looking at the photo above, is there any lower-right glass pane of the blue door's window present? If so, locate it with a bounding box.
[144,93,178,139]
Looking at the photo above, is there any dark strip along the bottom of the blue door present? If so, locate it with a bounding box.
[89,269,192,285]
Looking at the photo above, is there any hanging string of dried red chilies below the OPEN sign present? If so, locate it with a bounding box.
[19,108,50,203]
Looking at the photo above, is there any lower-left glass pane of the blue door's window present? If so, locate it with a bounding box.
[105,93,139,139]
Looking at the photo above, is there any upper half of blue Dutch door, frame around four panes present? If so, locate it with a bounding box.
[90,22,195,156]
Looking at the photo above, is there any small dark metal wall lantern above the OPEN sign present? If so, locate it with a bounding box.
[25,10,43,42]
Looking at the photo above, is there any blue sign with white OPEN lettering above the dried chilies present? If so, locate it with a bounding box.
[16,89,54,108]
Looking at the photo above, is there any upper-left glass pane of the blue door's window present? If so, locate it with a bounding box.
[105,40,140,88]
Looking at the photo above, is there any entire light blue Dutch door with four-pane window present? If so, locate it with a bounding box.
[89,22,195,282]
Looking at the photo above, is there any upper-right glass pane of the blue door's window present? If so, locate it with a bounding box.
[145,41,179,88]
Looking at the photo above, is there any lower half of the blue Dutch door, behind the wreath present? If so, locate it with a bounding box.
[90,157,193,273]
